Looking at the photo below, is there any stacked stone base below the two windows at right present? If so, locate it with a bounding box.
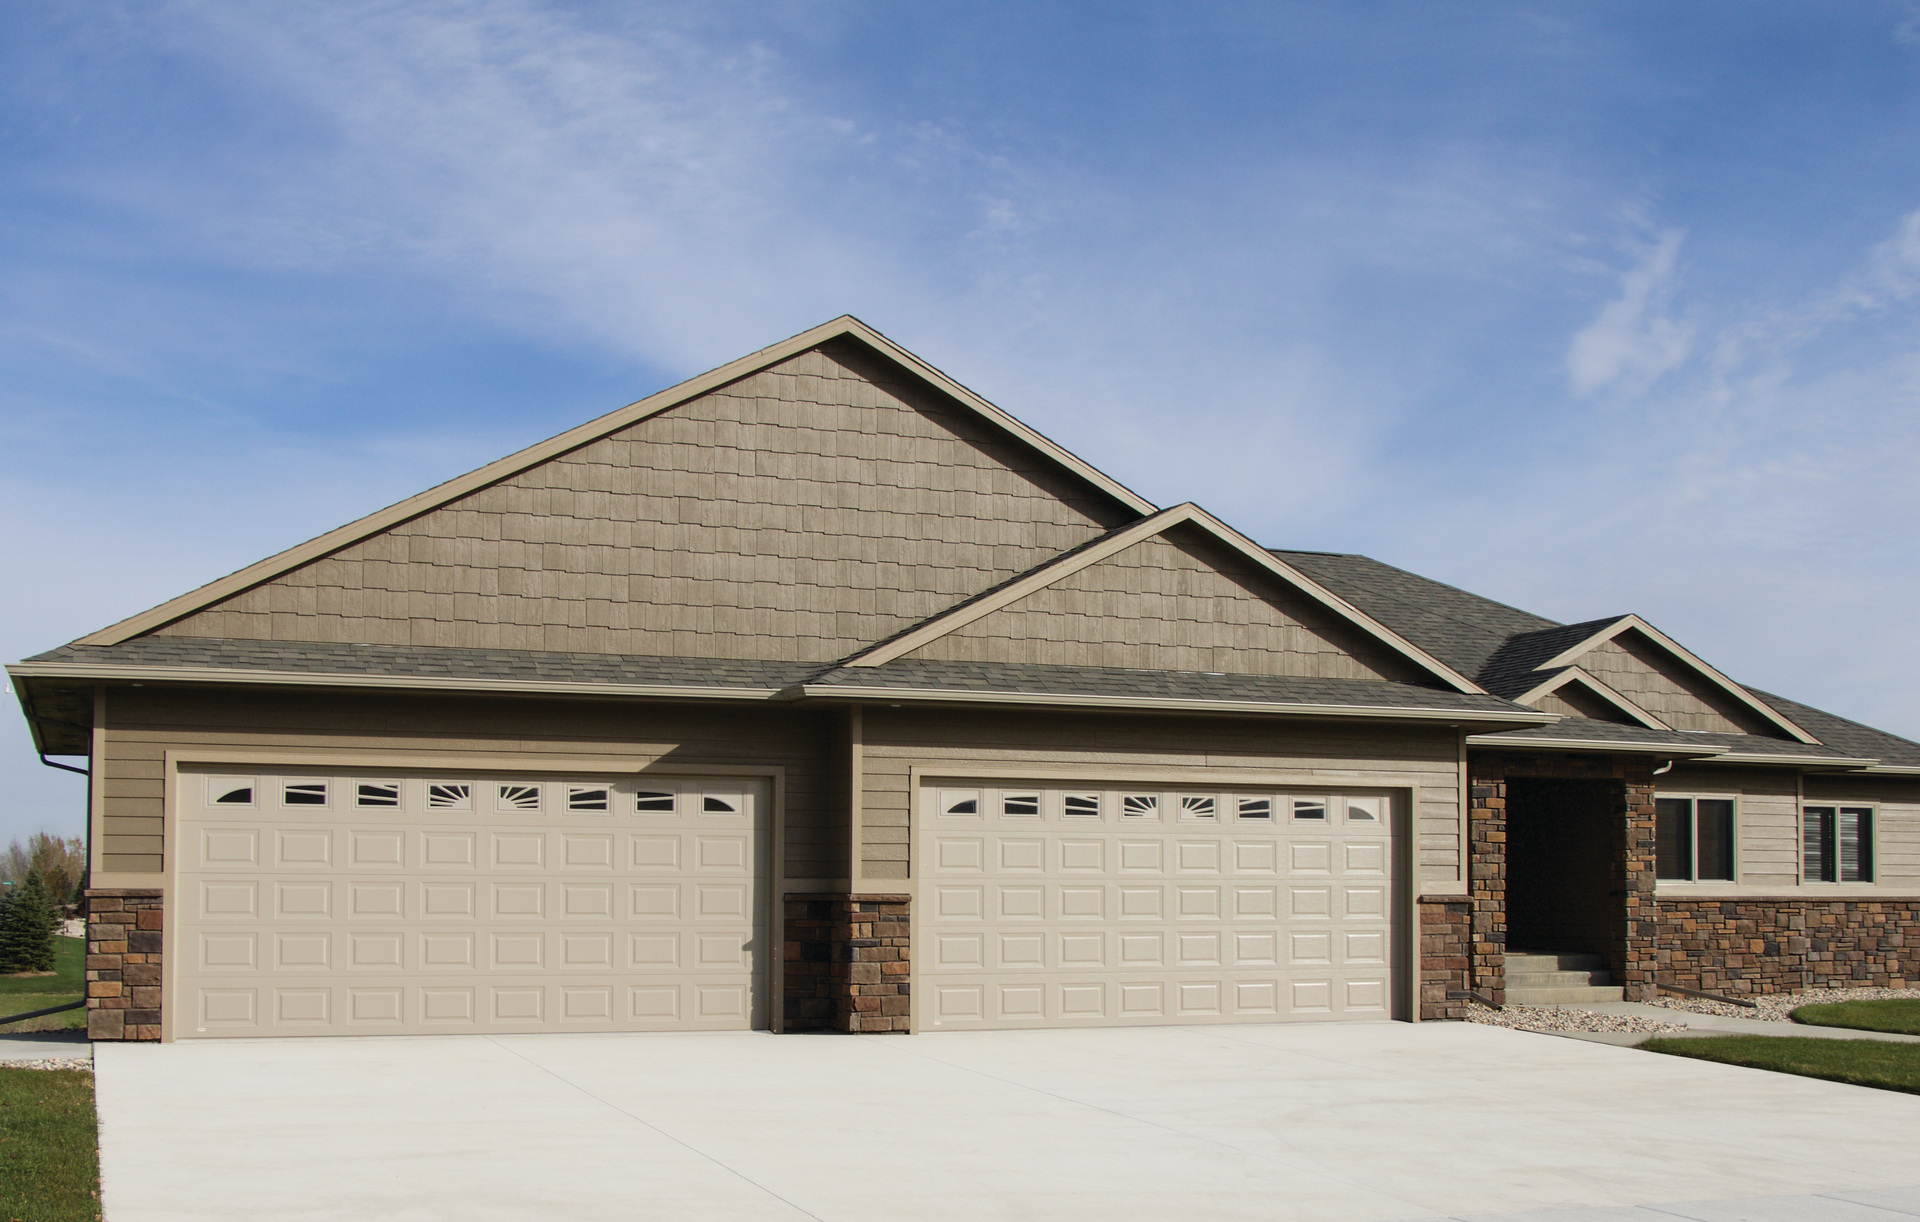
[1657,897,1920,995]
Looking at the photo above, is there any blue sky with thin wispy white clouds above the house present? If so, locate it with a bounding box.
[0,0,1920,836]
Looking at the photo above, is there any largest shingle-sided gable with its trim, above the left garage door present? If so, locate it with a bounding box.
[116,329,1150,661]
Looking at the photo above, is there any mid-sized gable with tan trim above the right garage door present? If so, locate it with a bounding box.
[849,503,1478,692]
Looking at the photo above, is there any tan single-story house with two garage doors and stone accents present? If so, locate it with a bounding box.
[8,319,1920,1039]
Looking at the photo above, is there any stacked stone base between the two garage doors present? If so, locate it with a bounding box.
[781,893,912,1032]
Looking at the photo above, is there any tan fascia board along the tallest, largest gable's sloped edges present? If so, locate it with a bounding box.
[75,315,1154,646]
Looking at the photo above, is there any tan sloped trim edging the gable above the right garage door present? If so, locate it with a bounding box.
[845,501,1484,694]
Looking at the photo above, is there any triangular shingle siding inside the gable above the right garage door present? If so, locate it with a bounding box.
[906,526,1421,680]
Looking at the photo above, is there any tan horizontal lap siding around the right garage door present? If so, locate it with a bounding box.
[860,709,1461,882]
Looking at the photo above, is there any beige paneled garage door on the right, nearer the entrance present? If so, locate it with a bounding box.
[920,782,1404,1030]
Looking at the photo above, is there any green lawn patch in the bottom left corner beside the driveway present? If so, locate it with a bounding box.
[0,1068,100,1222]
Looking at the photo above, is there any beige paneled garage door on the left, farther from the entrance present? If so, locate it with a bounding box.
[169,769,768,1039]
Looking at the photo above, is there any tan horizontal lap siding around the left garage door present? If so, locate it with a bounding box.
[98,690,845,878]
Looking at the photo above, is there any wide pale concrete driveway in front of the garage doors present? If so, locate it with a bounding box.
[96,1022,1920,1222]
